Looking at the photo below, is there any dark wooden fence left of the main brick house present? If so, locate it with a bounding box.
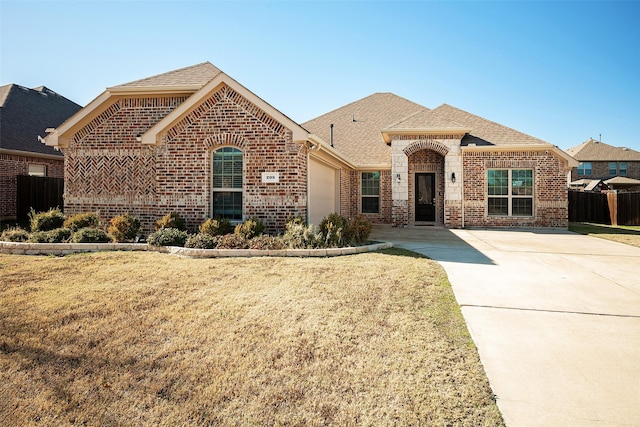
[16,175,64,219]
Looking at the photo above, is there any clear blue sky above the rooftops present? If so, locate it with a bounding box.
[0,0,640,151]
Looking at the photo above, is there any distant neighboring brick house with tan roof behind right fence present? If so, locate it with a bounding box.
[567,138,640,182]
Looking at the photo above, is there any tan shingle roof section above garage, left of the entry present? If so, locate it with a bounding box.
[302,93,428,167]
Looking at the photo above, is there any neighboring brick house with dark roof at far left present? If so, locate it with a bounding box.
[0,84,81,220]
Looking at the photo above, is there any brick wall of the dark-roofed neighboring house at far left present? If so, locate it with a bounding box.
[0,153,64,220]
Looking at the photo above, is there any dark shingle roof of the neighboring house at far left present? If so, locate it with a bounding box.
[0,84,81,157]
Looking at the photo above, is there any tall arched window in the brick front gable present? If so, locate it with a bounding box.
[212,147,242,221]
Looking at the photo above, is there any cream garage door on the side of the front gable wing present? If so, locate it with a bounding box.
[309,158,340,225]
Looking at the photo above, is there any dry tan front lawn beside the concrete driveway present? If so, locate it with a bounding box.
[0,250,502,426]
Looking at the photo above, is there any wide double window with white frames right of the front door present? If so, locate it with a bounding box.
[487,169,533,216]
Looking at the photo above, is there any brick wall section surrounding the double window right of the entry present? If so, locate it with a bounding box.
[463,150,568,228]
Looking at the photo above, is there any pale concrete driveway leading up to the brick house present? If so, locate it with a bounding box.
[372,226,640,427]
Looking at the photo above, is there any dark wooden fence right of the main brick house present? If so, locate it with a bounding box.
[569,190,640,225]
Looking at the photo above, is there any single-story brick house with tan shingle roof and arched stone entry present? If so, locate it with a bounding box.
[46,62,577,231]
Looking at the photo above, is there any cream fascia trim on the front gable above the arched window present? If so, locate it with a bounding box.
[141,73,309,145]
